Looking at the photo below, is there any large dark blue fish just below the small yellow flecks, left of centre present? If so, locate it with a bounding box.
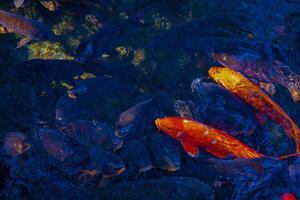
[56,76,135,123]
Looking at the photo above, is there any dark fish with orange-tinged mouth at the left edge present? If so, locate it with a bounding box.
[1,132,31,157]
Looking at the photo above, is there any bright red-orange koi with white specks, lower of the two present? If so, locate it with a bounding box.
[155,117,264,158]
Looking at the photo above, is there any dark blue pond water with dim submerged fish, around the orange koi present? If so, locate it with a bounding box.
[0,0,300,200]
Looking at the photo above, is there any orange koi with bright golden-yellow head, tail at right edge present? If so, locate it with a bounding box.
[208,67,300,153]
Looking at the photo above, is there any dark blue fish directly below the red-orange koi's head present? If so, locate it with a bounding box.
[147,134,181,172]
